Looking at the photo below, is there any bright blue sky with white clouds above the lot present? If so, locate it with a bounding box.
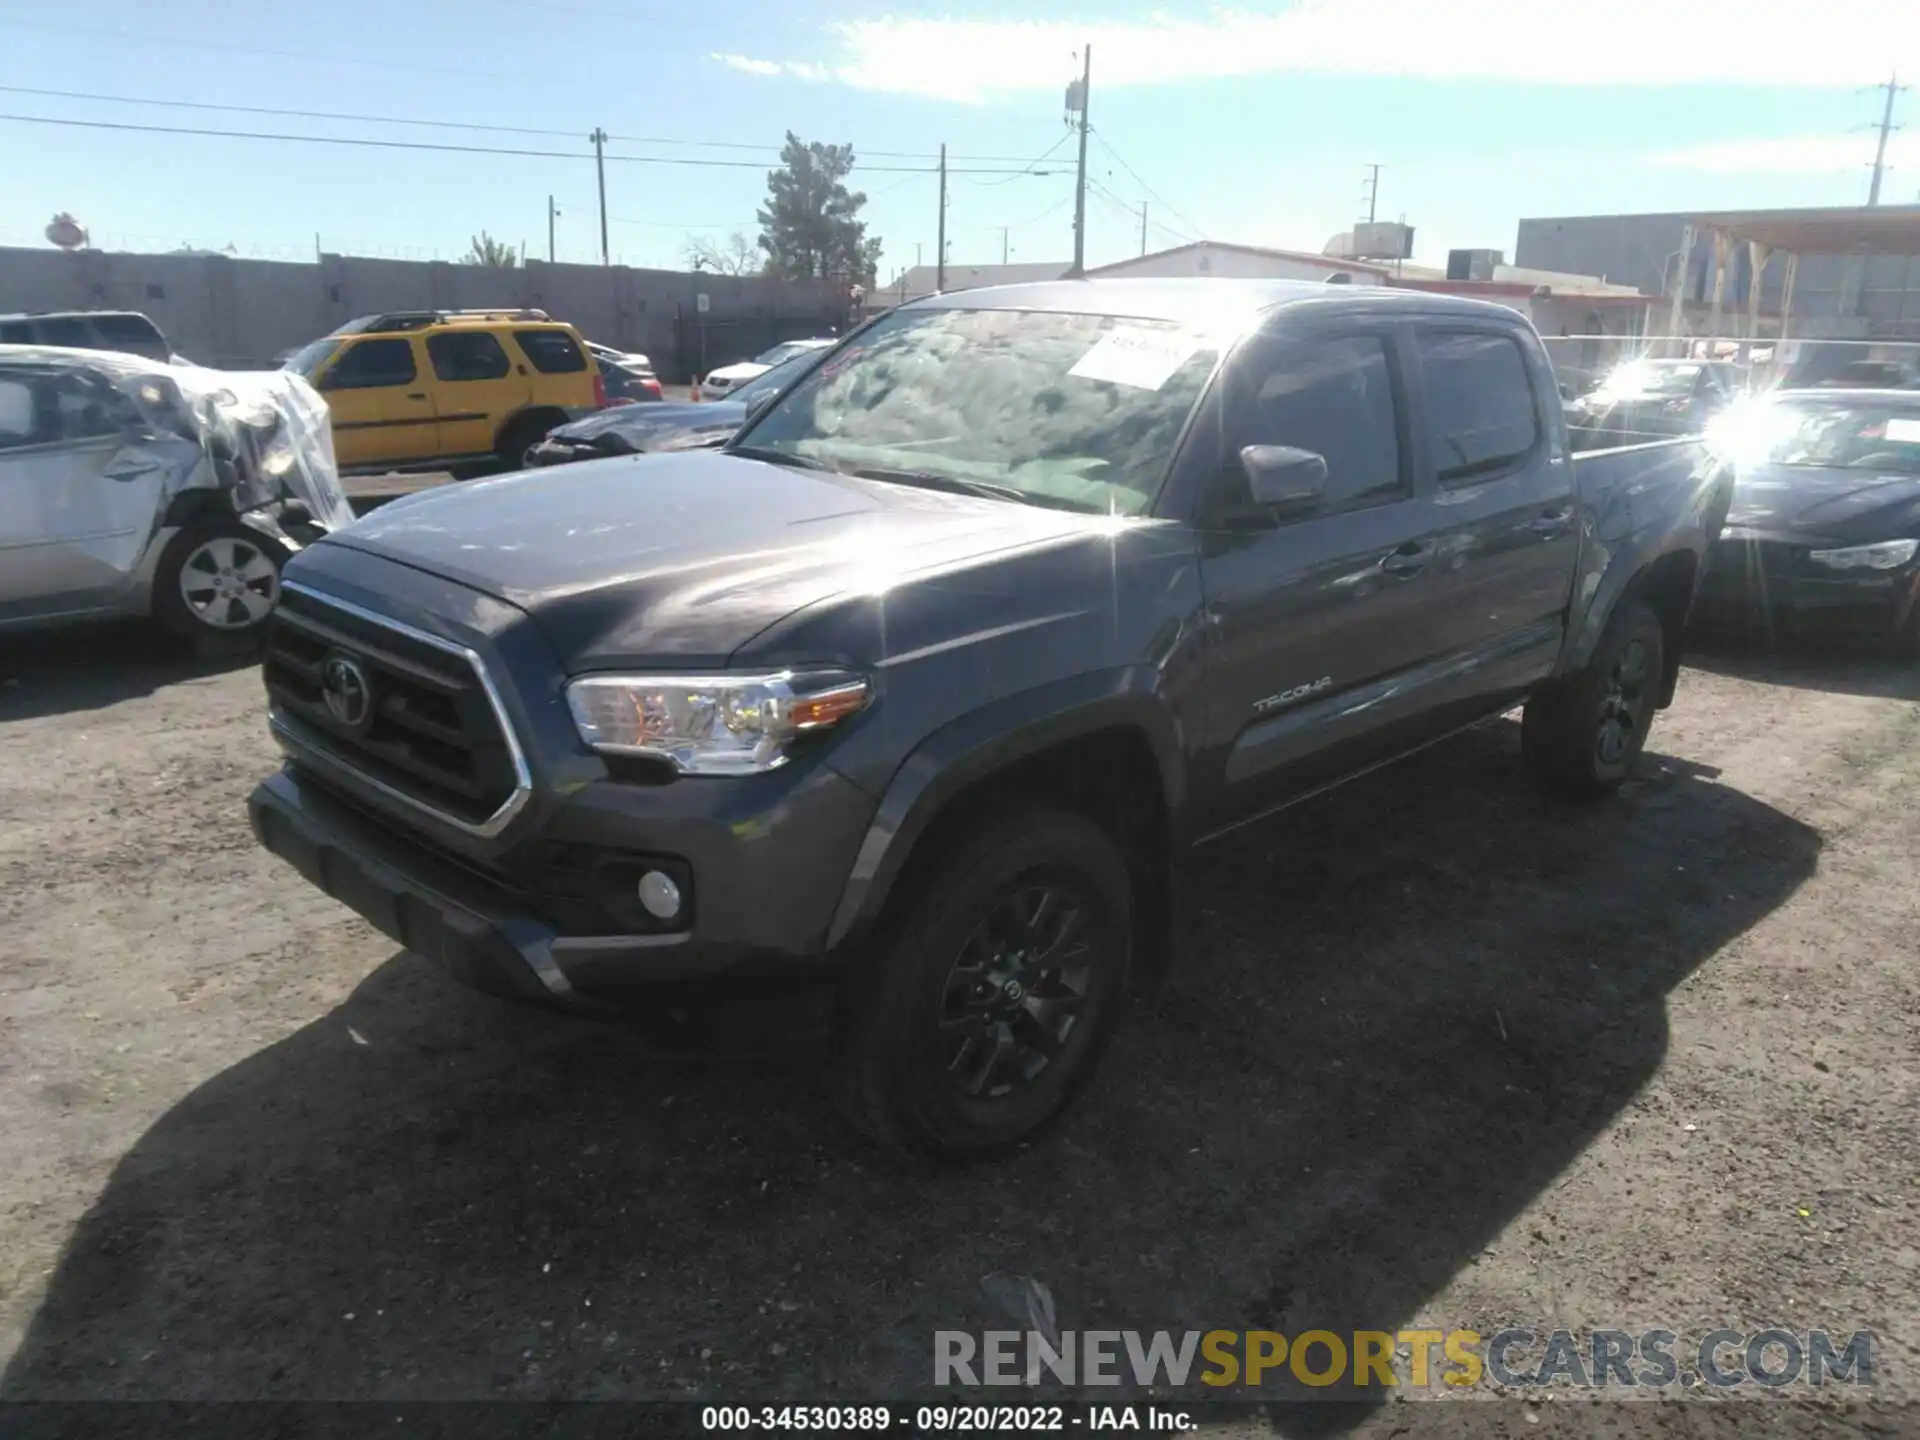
[0,0,1920,280]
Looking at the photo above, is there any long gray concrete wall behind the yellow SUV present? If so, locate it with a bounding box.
[0,248,847,380]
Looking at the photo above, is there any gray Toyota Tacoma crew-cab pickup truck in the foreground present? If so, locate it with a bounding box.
[250,280,1730,1158]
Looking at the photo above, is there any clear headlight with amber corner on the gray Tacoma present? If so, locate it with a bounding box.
[566,670,872,776]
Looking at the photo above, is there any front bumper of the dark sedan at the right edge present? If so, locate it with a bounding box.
[1693,534,1920,639]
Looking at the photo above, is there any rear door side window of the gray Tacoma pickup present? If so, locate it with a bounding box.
[1417,330,1540,486]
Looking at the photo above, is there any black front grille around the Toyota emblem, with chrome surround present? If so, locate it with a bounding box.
[261,586,526,833]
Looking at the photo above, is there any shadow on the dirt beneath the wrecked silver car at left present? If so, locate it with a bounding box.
[0,620,259,722]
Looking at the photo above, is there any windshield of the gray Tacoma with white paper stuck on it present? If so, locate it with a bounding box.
[741,309,1219,515]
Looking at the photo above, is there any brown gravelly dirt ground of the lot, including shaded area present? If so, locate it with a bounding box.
[0,630,1920,1434]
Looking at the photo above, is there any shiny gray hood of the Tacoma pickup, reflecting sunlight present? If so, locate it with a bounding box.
[324,451,1104,672]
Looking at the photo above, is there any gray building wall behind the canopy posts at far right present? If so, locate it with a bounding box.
[1515,215,1920,338]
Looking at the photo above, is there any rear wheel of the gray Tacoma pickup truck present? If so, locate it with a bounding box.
[1521,601,1667,801]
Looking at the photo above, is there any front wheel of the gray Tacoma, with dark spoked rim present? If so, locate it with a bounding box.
[835,806,1135,1162]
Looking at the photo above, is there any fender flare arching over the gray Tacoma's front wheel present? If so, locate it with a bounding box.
[828,666,1187,948]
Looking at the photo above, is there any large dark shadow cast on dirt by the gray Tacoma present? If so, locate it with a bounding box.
[0,722,1820,1432]
